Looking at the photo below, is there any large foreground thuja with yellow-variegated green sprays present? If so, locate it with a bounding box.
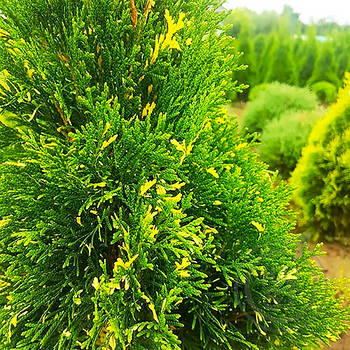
[0,0,349,350]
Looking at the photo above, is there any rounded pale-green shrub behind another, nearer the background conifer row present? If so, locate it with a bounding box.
[243,83,317,133]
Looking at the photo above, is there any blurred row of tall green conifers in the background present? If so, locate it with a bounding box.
[225,7,350,100]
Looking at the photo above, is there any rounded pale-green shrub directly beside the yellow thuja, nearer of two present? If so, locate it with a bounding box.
[258,109,325,179]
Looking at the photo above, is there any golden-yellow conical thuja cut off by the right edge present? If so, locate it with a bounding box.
[292,75,350,239]
